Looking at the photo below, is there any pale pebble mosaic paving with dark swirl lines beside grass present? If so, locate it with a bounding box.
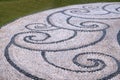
[0,2,120,80]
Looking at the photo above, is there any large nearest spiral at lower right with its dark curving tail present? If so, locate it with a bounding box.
[42,52,118,74]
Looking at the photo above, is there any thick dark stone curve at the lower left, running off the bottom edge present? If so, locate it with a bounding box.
[4,40,46,80]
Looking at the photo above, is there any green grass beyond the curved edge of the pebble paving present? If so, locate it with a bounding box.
[0,0,120,26]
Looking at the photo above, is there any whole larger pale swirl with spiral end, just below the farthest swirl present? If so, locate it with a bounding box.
[47,12,109,32]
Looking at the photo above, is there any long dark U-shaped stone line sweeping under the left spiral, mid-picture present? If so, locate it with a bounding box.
[11,30,106,52]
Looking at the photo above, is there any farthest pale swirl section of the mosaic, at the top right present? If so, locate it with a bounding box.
[61,4,120,19]
